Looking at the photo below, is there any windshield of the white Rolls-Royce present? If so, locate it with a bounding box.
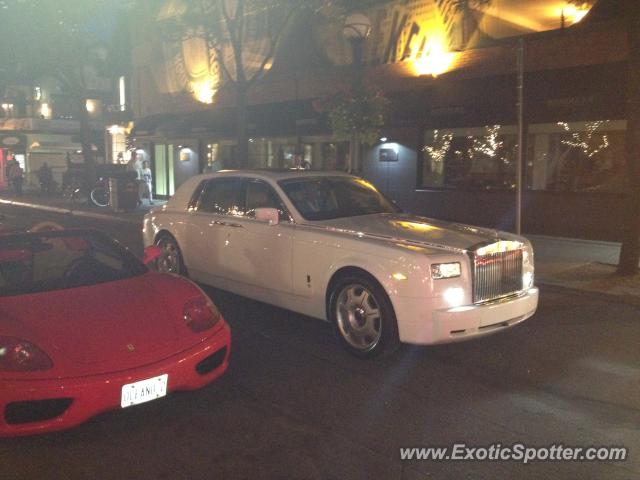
[280,177,400,220]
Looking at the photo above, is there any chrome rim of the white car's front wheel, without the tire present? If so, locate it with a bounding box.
[336,284,382,351]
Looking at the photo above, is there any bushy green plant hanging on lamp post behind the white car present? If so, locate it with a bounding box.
[314,78,389,173]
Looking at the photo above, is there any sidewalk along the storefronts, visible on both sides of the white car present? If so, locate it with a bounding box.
[0,192,640,306]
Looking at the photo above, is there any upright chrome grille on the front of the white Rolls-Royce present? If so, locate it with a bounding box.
[473,249,522,303]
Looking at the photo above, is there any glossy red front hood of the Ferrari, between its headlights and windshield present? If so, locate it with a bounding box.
[0,273,200,376]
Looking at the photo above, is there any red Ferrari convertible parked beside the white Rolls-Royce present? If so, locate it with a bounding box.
[0,230,231,436]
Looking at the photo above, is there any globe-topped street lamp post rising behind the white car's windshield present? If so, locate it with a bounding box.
[342,13,371,173]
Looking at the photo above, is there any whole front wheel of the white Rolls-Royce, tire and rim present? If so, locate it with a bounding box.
[329,274,400,358]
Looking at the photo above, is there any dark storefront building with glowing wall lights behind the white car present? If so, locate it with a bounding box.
[133,0,627,240]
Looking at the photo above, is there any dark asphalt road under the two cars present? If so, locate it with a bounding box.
[0,207,640,480]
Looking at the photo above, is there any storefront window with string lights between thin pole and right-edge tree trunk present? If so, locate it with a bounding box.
[527,120,626,192]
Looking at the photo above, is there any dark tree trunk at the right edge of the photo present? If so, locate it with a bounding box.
[618,0,640,275]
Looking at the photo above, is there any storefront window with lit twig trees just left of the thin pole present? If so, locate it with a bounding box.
[421,125,518,190]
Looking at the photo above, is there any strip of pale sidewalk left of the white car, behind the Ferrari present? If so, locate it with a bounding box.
[0,192,160,225]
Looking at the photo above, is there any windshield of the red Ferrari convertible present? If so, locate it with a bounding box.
[0,231,147,297]
